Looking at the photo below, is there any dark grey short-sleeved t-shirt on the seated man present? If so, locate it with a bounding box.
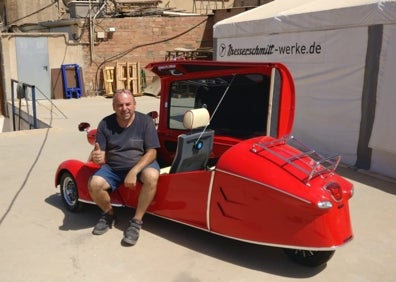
[96,111,160,170]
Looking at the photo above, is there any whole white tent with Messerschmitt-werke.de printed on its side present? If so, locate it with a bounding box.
[214,0,396,178]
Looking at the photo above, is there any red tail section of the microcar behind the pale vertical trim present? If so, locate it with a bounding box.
[210,138,352,248]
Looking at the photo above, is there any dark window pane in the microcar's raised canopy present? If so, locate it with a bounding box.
[169,74,270,138]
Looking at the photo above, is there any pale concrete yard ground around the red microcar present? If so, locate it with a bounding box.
[0,96,396,282]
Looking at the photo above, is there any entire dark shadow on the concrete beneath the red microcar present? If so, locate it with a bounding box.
[45,193,326,278]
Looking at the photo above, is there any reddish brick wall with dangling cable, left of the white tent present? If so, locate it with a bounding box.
[81,16,213,95]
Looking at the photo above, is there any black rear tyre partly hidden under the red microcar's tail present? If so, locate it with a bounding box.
[284,249,335,267]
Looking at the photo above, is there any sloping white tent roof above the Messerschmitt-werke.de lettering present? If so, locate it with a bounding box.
[214,0,396,38]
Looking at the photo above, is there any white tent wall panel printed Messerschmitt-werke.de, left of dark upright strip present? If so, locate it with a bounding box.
[216,27,368,164]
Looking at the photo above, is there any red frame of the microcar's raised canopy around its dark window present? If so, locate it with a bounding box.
[146,60,295,137]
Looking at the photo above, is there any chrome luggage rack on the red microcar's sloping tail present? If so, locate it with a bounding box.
[251,135,341,184]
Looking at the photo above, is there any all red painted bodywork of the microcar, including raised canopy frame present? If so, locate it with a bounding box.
[55,61,353,250]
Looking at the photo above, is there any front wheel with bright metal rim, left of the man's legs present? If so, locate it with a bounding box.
[60,171,82,212]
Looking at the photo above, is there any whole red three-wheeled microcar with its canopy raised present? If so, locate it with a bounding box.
[55,61,353,266]
